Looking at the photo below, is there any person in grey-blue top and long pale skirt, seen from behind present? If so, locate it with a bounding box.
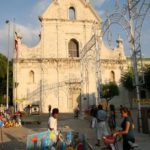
[95,105,109,146]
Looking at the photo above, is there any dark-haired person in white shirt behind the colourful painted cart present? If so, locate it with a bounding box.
[48,108,59,135]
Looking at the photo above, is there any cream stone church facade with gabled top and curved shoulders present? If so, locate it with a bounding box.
[13,0,127,112]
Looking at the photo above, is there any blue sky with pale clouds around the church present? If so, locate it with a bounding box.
[0,0,150,58]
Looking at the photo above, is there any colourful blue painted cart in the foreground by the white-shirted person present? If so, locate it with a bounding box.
[26,126,93,150]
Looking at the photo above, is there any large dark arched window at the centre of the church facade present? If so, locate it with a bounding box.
[68,39,79,57]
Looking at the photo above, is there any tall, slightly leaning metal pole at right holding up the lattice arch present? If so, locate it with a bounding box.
[128,0,141,132]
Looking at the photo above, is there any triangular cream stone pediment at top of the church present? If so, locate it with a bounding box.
[40,0,101,23]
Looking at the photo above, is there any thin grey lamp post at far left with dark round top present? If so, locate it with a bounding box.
[6,20,10,109]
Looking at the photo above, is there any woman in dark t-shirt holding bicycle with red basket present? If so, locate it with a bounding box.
[113,107,135,150]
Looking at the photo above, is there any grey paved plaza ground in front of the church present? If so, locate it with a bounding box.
[0,110,150,150]
